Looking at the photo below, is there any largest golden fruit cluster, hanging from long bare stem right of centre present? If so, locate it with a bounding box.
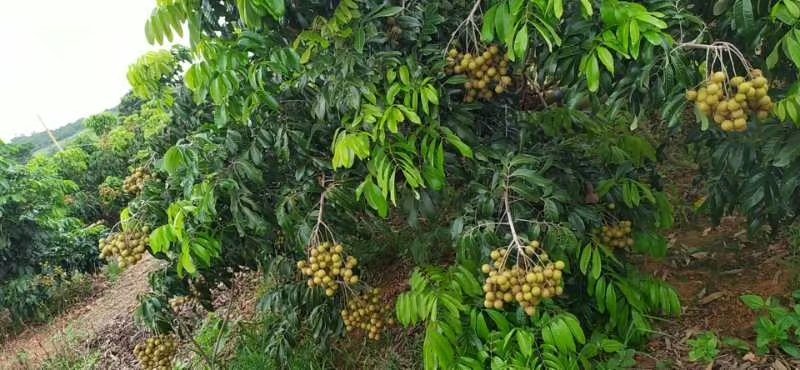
[481,240,566,316]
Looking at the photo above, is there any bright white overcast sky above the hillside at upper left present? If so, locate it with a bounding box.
[0,0,180,141]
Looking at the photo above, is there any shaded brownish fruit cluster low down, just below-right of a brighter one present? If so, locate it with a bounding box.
[342,288,394,340]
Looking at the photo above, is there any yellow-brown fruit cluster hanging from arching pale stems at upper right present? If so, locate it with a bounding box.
[686,69,774,132]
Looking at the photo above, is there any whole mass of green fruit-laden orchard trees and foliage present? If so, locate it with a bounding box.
[0,0,800,369]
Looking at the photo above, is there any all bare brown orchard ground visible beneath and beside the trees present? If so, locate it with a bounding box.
[0,217,800,369]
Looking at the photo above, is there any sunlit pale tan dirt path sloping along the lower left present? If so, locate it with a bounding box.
[0,258,161,370]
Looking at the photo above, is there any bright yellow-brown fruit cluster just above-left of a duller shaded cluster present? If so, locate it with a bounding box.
[297,242,358,297]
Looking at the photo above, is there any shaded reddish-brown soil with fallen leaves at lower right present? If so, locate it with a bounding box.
[638,218,800,370]
